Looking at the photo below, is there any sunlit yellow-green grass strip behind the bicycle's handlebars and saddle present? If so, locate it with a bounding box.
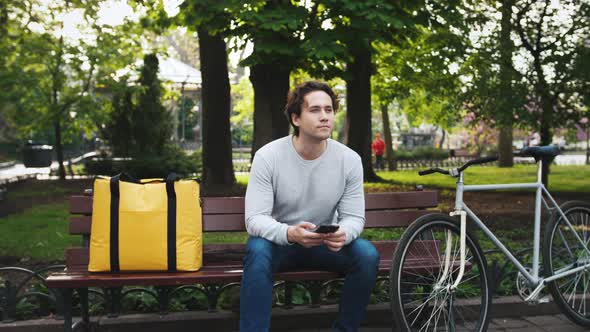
[376,165,590,192]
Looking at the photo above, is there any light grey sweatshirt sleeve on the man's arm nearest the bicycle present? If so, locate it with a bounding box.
[337,156,365,244]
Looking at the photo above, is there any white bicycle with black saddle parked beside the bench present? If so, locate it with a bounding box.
[390,146,590,331]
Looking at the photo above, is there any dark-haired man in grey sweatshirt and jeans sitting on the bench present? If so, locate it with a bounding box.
[240,81,379,332]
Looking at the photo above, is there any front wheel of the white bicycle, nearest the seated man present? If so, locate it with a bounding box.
[390,214,491,332]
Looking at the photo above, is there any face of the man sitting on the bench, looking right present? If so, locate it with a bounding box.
[291,91,334,141]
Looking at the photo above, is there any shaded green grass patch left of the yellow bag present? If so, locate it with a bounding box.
[0,203,81,262]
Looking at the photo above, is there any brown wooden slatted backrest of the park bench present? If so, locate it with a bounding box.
[66,191,438,271]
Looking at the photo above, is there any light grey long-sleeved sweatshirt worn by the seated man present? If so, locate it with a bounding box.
[246,135,365,245]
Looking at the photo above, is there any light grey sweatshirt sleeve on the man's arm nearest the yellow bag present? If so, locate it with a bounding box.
[245,153,289,245]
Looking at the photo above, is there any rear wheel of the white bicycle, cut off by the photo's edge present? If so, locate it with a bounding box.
[543,201,590,327]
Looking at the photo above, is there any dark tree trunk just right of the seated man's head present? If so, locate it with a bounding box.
[346,45,381,182]
